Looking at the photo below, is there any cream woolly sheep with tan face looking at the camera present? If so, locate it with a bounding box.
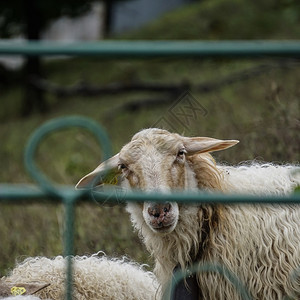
[76,128,300,300]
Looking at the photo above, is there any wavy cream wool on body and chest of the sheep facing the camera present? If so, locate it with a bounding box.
[127,163,300,300]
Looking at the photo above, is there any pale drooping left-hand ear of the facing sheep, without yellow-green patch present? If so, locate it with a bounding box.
[75,153,119,189]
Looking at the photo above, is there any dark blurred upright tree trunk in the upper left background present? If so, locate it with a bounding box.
[21,0,47,116]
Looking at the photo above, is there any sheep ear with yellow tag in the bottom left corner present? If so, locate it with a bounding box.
[0,281,50,297]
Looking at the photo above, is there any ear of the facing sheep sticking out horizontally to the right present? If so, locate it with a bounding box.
[183,137,239,155]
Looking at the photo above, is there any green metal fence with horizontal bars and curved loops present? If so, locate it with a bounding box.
[0,41,300,299]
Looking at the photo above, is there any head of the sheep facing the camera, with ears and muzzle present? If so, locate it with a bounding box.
[76,128,238,233]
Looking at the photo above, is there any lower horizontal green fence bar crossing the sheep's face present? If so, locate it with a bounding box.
[0,184,300,204]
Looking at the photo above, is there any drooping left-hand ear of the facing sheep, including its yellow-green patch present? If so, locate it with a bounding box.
[75,153,120,189]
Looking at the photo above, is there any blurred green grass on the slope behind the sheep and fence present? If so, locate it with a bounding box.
[0,0,300,274]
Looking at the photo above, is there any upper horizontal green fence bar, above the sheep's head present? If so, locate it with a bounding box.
[0,40,300,58]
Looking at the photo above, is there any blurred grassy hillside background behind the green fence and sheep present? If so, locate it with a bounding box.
[0,0,300,275]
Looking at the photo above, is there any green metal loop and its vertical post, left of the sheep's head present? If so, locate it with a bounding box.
[24,116,111,300]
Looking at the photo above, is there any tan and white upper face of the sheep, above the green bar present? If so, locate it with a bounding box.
[118,129,186,193]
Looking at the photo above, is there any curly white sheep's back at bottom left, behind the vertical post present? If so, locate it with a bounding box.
[0,255,159,300]
